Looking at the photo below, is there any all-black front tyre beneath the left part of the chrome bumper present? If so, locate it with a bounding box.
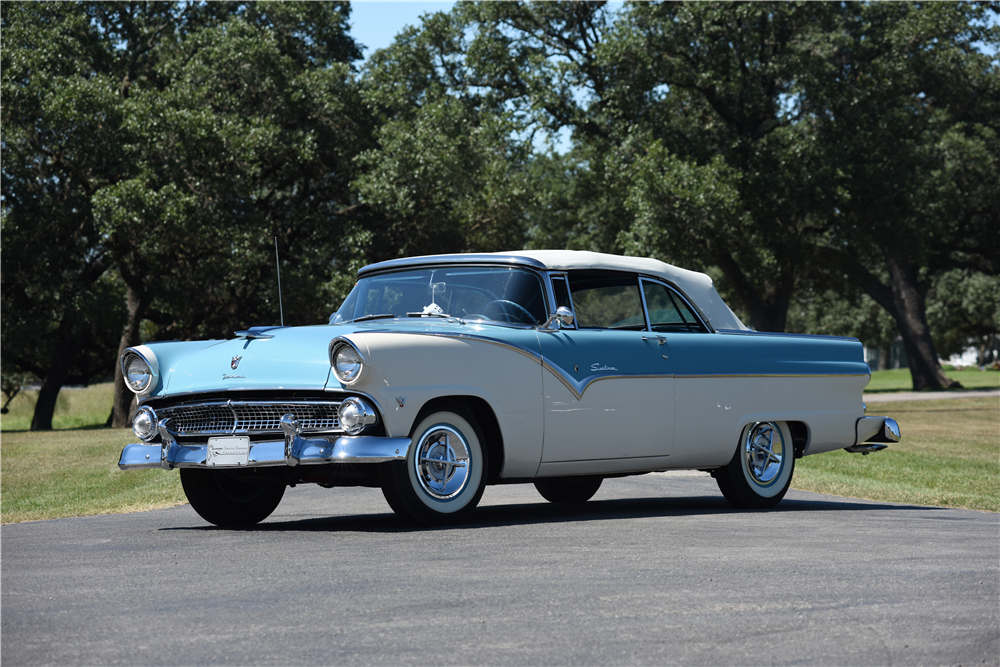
[181,468,285,526]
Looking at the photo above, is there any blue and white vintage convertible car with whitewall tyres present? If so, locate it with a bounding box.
[119,250,899,525]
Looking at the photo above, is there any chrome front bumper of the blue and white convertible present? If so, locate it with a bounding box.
[118,418,410,470]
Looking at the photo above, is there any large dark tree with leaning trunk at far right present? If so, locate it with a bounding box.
[810,3,1000,390]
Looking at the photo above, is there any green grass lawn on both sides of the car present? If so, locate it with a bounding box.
[0,380,1000,523]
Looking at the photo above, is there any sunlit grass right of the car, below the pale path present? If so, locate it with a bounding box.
[792,398,1000,512]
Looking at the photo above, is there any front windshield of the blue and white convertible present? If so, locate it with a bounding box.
[330,266,545,326]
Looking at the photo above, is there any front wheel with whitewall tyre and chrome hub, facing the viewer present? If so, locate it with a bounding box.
[379,406,487,526]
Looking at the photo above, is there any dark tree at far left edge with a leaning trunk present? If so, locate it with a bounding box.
[0,2,123,430]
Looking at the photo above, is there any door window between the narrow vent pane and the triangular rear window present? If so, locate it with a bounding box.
[569,273,646,330]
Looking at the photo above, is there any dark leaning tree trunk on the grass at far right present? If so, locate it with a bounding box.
[873,255,962,391]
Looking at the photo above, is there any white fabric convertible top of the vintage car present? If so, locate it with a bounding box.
[504,250,747,330]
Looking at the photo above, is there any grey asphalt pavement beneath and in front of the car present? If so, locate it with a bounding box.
[0,472,1000,667]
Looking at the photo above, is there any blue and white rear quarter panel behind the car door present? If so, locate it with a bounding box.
[668,333,871,467]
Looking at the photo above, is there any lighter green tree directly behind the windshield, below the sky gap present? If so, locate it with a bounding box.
[354,7,530,259]
